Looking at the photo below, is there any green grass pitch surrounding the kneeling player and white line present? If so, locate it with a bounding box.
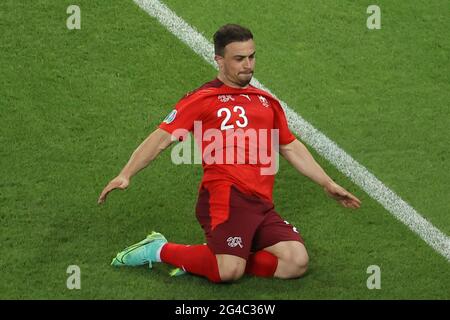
[0,0,450,299]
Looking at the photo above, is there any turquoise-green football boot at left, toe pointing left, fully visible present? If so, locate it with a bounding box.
[111,231,167,268]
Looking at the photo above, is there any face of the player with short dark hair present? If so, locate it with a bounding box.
[221,40,255,87]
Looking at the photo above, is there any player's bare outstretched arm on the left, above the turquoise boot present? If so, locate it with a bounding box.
[98,128,173,203]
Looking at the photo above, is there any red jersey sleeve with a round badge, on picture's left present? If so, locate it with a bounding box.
[158,93,206,141]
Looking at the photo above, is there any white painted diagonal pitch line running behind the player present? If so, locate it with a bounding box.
[133,0,450,262]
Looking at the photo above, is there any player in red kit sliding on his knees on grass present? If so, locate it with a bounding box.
[98,24,361,282]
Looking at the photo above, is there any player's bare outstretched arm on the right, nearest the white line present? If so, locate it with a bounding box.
[280,139,361,209]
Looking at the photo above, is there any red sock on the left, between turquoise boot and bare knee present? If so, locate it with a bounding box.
[160,243,221,282]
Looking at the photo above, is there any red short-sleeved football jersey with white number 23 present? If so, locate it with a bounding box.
[159,78,295,202]
